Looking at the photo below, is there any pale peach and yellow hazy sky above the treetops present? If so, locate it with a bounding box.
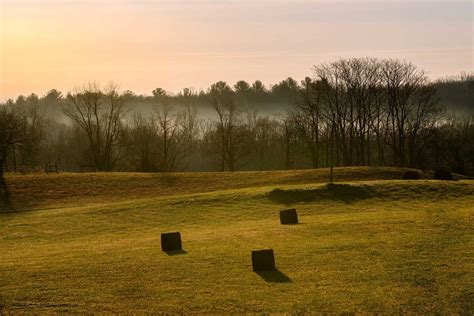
[0,0,474,100]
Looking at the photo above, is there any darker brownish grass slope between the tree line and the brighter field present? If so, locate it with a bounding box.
[3,167,429,210]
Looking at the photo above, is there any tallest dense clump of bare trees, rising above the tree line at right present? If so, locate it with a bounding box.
[291,58,439,167]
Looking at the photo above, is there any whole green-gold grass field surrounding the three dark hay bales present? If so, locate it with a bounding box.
[0,168,474,314]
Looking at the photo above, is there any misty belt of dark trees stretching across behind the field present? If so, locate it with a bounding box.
[0,58,474,179]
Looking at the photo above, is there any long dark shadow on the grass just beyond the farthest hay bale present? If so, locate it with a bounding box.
[268,183,376,205]
